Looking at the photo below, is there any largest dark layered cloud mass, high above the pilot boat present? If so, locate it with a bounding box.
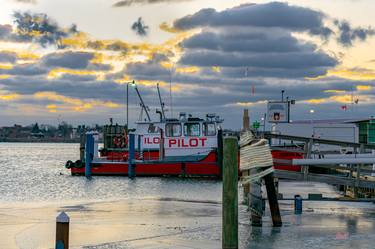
[170,2,344,79]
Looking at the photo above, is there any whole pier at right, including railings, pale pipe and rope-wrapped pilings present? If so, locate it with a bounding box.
[232,131,375,233]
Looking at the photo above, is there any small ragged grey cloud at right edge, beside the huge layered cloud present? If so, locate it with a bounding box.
[335,20,375,46]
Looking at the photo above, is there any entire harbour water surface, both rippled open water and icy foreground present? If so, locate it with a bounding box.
[0,143,375,249]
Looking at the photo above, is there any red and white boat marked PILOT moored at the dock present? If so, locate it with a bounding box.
[66,83,223,177]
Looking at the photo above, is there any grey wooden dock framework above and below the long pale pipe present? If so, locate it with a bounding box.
[263,133,375,198]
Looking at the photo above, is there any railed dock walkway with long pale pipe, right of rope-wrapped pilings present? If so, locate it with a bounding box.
[263,133,375,198]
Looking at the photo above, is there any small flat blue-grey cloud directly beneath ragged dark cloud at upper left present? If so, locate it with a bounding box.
[41,51,94,69]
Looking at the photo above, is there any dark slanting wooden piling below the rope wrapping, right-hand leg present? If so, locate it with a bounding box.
[264,174,283,227]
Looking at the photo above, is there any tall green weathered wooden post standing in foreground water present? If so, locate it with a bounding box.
[222,137,238,249]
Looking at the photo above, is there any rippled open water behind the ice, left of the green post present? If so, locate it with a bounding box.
[0,143,221,202]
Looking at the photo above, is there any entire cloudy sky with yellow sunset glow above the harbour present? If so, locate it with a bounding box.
[0,0,375,128]
